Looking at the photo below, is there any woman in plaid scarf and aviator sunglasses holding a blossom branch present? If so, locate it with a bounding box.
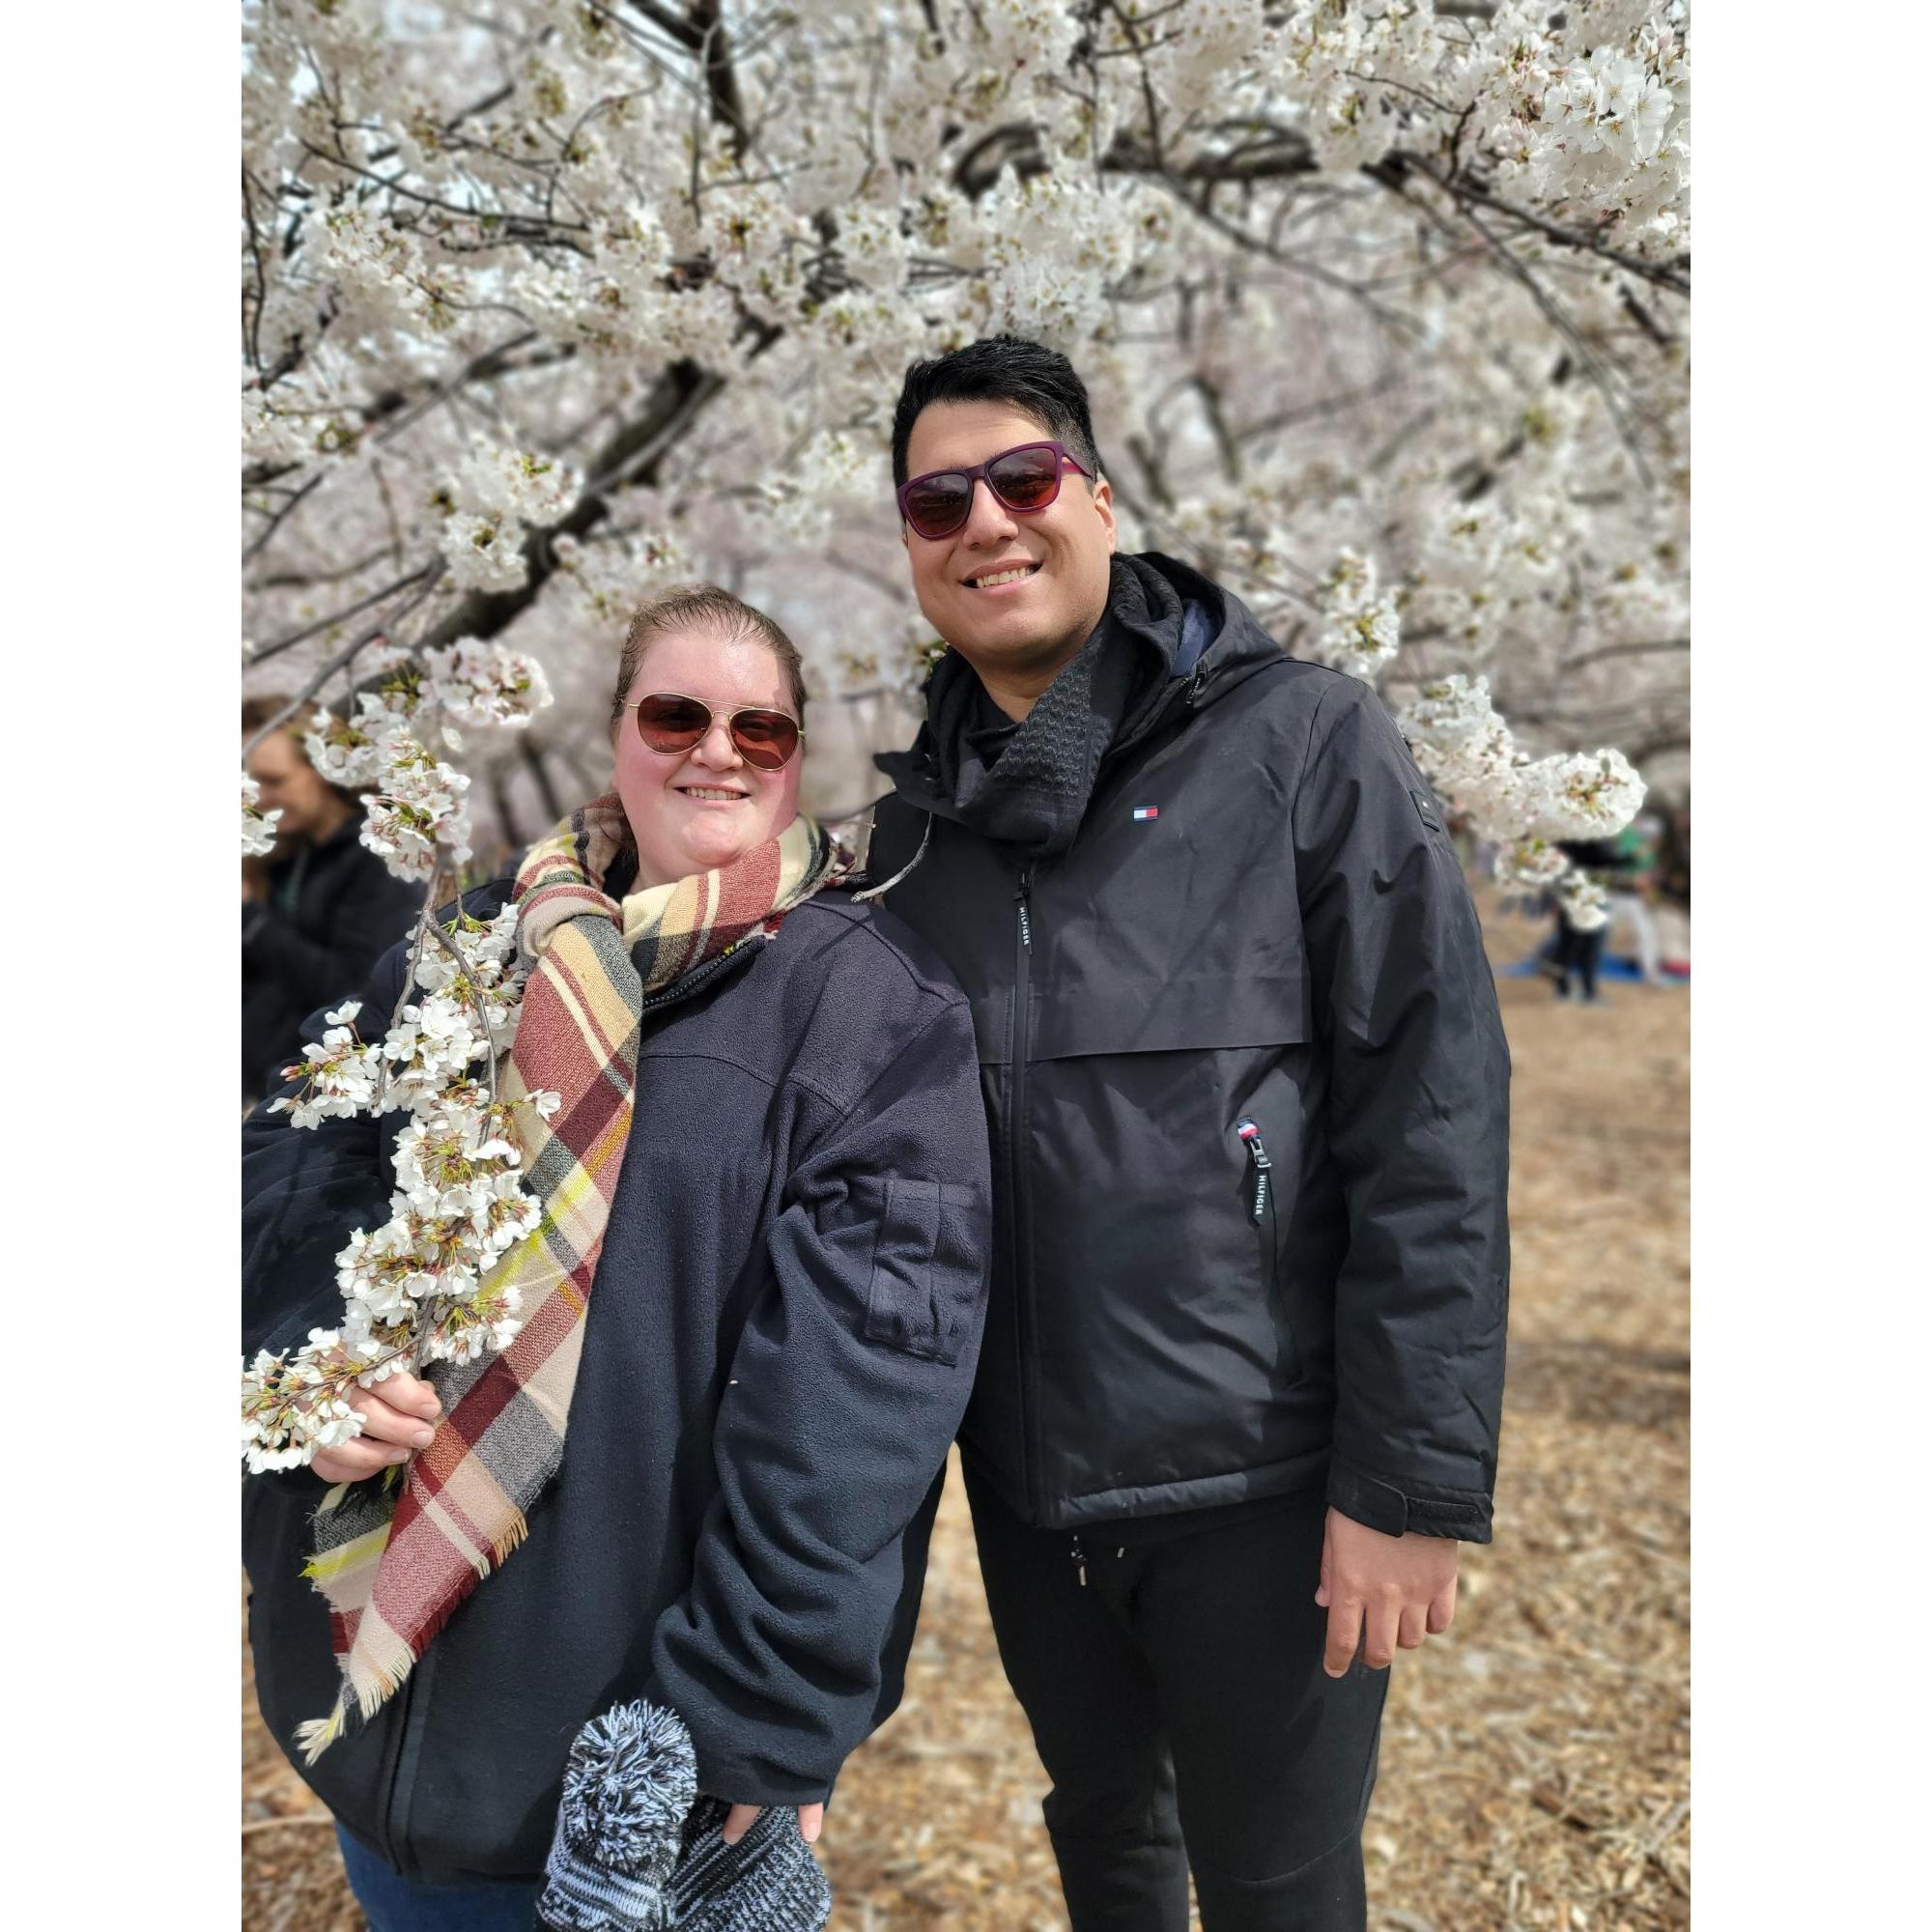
[243,587,989,1932]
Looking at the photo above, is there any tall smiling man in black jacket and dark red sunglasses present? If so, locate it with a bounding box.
[871,336,1509,1932]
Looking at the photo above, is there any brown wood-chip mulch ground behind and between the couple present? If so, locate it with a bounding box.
[242,904,1690,1932]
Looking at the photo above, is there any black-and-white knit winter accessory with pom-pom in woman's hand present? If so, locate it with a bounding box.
[537,1702,833,1932]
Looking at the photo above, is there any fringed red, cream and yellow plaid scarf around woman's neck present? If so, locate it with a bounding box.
[296,792,852,1764]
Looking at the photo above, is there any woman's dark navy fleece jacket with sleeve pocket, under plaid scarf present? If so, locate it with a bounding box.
[242,885,989,1880]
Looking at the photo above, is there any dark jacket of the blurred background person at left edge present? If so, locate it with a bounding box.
[242,811,423,1099]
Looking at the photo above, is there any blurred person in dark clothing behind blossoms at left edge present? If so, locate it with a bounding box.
[242,697,423,1101]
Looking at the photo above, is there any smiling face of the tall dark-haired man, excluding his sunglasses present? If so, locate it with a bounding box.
[902,402,1115,676]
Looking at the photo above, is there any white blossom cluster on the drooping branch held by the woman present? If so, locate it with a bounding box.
[242,904,558,1470]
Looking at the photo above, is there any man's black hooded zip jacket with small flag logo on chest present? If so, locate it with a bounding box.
[869,556,1509,1542]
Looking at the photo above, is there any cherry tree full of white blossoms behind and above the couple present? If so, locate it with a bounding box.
[242,0,1690,1453]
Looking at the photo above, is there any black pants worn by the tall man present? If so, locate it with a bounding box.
[966,1468,1389,1932]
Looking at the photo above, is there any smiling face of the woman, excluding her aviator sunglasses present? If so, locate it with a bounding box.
[616,630,804,887]
